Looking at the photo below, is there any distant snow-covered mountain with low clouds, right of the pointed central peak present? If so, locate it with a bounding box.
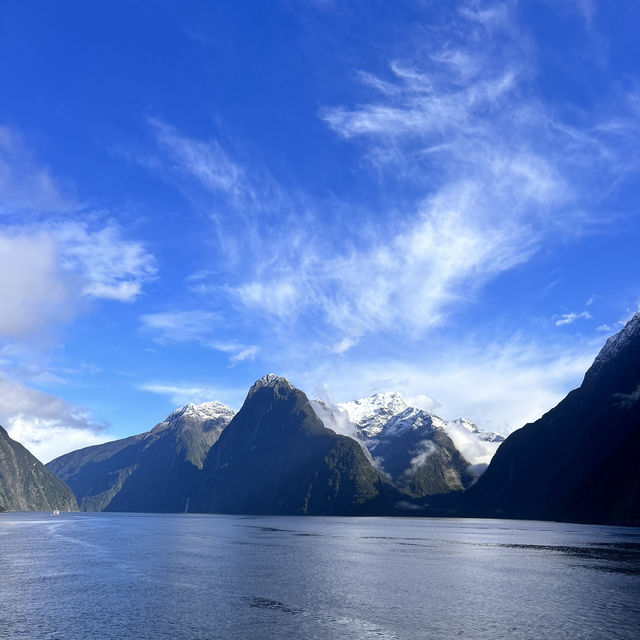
[312,393,504,497]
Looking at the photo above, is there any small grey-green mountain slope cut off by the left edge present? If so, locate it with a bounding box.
[0,427,78,511]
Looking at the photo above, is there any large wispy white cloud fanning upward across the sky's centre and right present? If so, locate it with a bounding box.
[135,2,632,394]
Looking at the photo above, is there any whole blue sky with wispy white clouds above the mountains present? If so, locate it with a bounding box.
[0,0,640,461]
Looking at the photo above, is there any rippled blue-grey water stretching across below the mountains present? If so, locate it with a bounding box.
[0,513,640,640]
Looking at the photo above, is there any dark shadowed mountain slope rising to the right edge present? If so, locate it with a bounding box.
[463,313,640,525]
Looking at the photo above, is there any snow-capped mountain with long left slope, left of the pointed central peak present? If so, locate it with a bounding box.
[47,402,233,512]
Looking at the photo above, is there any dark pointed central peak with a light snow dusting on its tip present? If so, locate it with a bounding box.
[194,374,396,515]
